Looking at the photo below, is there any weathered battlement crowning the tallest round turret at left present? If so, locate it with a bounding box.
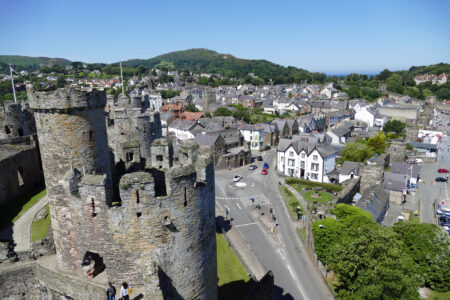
[27,84,106,110]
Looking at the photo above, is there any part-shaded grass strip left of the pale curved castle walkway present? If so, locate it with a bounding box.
[0,187,47,229]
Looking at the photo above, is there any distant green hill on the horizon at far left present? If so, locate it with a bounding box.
[0,55,70,72]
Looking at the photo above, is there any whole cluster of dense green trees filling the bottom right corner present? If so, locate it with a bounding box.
[312,204,450,299]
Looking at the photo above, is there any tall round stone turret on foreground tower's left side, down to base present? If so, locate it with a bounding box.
[27,84,111,270]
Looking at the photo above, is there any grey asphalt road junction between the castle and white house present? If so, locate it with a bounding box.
[216,151,334,300]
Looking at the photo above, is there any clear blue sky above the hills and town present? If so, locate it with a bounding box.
[0,0,450,73]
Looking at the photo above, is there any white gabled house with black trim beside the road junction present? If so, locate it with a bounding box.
[277,139,336,183]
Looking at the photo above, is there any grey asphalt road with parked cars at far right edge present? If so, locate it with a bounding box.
[418,136,450,223]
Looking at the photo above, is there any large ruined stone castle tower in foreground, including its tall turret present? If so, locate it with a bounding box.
[27,85,217,299]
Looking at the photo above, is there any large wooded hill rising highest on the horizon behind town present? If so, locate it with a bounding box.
[118,49,318,78]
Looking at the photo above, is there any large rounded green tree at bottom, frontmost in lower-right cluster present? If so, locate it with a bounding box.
[330,223,418,299]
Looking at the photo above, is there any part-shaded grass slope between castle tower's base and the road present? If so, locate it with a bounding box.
[216,233,253,300]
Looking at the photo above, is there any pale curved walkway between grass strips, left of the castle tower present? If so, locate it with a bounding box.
[12,196,48,252]
